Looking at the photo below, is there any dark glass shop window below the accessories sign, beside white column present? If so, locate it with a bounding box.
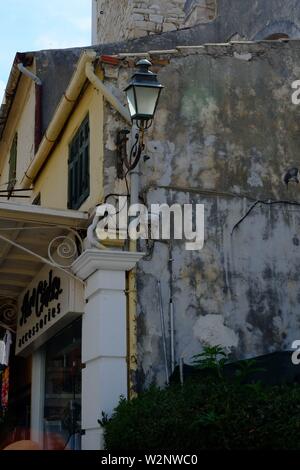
[44,319,81,450]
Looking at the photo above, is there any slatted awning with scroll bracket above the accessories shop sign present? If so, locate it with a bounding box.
[0,202,89,328]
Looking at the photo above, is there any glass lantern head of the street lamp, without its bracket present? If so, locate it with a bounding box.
[124,59,164,129]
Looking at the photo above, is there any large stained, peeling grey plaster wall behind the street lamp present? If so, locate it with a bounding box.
[104,41,300,385]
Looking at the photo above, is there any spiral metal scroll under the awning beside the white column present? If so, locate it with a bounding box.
[48,229,83,268]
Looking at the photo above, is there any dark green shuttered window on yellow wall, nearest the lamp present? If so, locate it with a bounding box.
[68,116,90,209]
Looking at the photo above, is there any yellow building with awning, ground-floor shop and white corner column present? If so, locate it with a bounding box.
[0,50,141,450]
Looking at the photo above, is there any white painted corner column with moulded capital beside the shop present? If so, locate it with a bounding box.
[72,249,143,450]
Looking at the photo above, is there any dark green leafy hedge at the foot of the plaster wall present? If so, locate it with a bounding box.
[102,364,300,452]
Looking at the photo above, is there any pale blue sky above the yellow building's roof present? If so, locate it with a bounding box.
[0,0,92,104]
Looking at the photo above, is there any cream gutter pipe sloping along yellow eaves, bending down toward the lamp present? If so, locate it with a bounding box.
[20,50,131,189]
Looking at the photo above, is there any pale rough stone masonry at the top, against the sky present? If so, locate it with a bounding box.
[93,0,215,44]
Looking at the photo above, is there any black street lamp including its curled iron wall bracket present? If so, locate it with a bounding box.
[116,59,164,178]
